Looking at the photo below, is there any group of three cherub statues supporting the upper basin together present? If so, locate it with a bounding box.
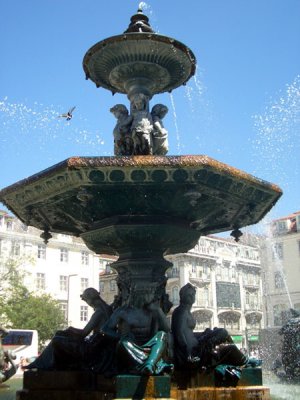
[110,93,168,156]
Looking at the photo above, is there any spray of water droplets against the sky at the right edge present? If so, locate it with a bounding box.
[252,75,300,188]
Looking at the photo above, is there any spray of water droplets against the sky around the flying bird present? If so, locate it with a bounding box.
[0,97,104,155]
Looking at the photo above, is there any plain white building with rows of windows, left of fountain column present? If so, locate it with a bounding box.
[0,211,106,328]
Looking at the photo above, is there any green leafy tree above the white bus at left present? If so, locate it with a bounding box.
[0,258,65,346]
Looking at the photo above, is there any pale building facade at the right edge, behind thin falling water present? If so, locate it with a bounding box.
[261,211,300,328]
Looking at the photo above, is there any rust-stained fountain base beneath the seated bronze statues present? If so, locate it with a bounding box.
[16,368,270,400]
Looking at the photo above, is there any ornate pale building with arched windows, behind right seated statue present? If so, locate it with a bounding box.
[100,236,263,349]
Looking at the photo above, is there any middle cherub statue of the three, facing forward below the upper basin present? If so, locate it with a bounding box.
[131,93,153,155]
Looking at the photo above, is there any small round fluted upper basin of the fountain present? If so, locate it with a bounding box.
[83,32,196,98]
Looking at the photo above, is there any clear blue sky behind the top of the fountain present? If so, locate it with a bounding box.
[0,0,300,228]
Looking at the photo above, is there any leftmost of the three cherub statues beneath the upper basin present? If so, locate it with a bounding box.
[110,104,133,156]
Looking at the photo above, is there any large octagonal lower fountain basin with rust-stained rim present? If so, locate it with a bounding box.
[0,156,282,254]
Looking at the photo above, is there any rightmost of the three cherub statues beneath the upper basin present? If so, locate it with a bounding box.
[151,104,169,156]
